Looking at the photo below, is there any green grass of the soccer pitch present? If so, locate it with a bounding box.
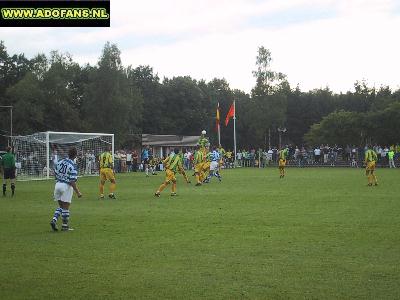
[0,168,400,299]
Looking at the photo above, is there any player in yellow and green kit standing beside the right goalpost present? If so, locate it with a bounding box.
[99,147,116,199]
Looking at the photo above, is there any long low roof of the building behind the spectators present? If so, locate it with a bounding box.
[142,134,200,147]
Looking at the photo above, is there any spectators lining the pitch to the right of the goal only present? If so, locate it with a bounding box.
[111,144,400,172]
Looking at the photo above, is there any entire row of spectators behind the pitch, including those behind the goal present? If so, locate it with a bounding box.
[16,144,400,176]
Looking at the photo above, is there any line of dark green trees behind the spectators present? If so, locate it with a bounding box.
[0,42,400,149]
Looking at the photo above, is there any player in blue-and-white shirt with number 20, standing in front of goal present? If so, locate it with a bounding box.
[50,148,82,231]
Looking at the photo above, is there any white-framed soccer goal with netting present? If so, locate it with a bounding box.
[12,131,114,180]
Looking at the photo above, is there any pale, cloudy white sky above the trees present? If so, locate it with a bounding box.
[0,0,400,93]
